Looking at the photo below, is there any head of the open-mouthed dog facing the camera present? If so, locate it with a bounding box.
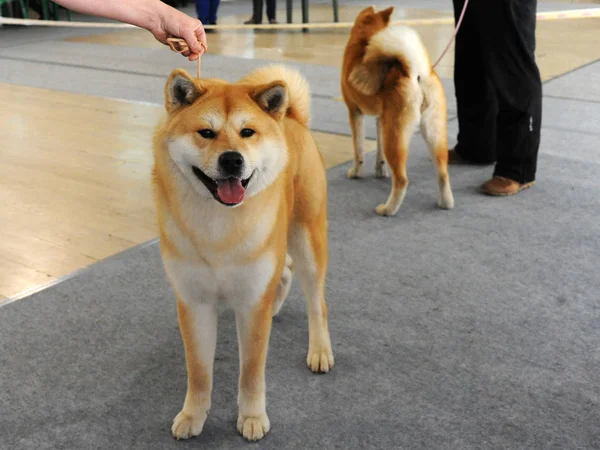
[158,69,288,207]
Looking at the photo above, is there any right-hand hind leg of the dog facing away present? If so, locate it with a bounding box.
[421,75,454,209]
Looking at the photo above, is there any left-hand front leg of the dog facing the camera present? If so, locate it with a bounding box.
[171,299,217,439]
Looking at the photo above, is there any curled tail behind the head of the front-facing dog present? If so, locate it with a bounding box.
[240,64,310,128]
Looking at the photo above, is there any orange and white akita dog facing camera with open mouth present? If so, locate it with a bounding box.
[153,66,334,440]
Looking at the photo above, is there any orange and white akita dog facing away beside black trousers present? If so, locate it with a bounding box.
[341,6,454,216]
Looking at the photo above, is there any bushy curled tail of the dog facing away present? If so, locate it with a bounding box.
[348,27,432,95]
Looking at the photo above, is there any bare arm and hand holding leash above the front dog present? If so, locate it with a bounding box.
[56,0,206,61]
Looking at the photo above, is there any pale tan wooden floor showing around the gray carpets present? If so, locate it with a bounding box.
[0,4,600,303]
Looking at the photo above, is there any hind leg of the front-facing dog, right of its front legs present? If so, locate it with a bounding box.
[290,221,334,372]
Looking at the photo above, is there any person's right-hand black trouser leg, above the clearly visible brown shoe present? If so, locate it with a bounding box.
[482,0,542,183]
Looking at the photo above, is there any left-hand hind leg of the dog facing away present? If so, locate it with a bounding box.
[375,104,419,216]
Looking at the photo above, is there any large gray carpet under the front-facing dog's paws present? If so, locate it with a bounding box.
[0,120,600,450]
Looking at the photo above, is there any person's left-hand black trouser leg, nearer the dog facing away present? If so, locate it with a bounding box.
[453,0,498,163]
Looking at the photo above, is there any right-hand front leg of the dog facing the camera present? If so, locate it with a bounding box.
[235,290,277,441]
